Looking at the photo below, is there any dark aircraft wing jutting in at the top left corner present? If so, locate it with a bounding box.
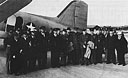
[0,0,32,22]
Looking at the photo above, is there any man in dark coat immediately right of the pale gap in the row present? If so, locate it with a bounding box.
[50,28,60,67]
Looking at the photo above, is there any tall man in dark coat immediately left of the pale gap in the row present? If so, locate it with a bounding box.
[37,26,48,69]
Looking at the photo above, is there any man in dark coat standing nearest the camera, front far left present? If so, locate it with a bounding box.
[7,33,21,75]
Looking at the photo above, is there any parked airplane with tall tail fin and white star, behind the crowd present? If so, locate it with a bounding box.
[0,0,88,38]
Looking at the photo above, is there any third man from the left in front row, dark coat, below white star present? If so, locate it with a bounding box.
[28,31,39,72]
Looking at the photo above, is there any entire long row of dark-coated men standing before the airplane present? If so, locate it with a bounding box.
[5,26,127,75]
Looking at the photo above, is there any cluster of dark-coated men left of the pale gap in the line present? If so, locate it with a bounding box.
[4,27,48,75]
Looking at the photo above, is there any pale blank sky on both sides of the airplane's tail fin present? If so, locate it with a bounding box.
[21,0,128,26]
